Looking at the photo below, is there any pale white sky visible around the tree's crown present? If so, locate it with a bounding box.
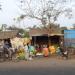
[0,0,75,28]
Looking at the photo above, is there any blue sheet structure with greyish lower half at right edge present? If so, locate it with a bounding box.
[64,30,75,47]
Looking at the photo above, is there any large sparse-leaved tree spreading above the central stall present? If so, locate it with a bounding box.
[19,0,72,27]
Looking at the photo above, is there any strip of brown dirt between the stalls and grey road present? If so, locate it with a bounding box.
[0,58,75,69]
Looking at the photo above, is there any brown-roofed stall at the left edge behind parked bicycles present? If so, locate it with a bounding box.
[0,30,18,45]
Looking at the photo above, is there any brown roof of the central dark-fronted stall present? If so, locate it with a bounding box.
[29,28,63,36]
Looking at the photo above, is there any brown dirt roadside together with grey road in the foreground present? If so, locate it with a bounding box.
[0,57,75,75]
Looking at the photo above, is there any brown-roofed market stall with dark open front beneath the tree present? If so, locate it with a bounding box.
[29,26,63,45]
